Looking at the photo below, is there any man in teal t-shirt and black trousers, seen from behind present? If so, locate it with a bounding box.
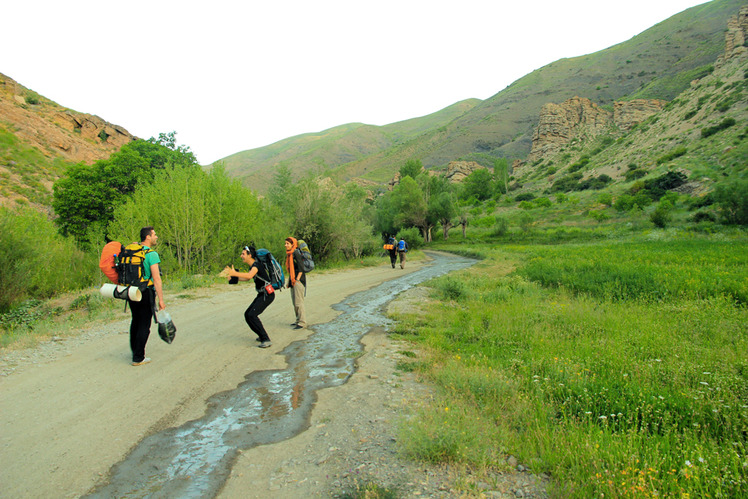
[126,227,166,366]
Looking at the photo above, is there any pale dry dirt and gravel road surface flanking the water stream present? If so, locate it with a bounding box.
[0,256,548,498]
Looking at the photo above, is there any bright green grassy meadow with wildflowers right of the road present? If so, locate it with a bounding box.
[395,237,748,497]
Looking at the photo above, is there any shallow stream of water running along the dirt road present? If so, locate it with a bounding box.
[87,253,475,498]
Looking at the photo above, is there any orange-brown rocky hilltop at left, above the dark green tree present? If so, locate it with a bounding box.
[0,74,136,163]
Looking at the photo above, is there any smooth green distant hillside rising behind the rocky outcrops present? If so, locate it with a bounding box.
[215,0,744,191]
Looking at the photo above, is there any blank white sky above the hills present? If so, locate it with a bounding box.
[0,0,705,164]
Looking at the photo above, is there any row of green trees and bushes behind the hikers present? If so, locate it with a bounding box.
[0,132,506,311]
